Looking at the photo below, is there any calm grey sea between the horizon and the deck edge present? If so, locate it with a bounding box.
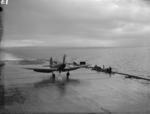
[4,47,150,75]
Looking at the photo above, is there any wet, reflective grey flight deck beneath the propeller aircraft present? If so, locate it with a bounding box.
[1,65,150,113]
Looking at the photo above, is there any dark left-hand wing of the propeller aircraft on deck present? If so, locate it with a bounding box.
[25,68,57,73]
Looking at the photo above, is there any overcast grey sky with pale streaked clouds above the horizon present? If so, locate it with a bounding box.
[2,0,150,47]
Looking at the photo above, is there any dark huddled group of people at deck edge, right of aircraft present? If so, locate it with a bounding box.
[92,65,112,74]
